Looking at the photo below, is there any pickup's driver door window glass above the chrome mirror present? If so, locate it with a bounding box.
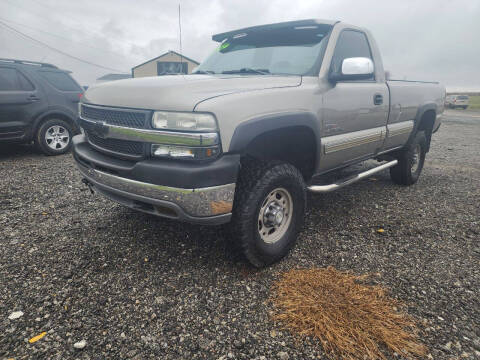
[330,30,373,78]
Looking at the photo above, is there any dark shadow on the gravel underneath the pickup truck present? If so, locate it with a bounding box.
[85,173,398,273]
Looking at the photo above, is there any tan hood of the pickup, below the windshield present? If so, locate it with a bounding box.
[83,75,302,111]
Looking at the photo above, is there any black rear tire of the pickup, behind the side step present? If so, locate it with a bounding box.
[390,131,427,185]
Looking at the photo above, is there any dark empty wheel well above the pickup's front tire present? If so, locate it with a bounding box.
[244,126,317,181]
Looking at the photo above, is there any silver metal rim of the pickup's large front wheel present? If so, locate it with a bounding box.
[258,188,293,244]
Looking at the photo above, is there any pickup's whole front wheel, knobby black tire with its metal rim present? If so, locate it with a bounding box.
[229,162,306,267]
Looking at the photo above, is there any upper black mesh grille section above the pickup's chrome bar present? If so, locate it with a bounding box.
[81,104,148,129]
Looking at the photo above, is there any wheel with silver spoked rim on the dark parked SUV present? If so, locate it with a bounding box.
[35,119,73,155]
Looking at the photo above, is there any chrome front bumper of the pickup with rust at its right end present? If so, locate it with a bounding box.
[76,161,235,224]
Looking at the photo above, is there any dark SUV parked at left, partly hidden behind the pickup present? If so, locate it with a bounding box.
[0,59,83,155]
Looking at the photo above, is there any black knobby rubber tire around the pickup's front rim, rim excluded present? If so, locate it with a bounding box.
[228,159,306,267]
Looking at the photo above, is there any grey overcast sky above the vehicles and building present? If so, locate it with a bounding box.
[0,0,480,90]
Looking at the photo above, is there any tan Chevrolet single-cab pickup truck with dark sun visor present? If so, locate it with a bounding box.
[73,20,445,267]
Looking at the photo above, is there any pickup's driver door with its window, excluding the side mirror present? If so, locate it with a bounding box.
[320,30,389,171]
